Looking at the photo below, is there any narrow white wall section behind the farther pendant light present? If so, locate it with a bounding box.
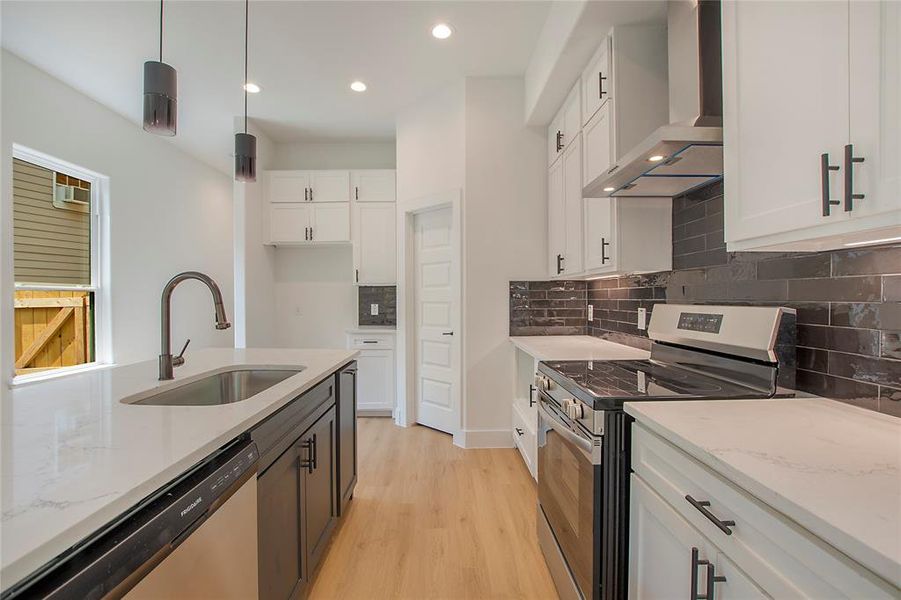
[232,117,276,348]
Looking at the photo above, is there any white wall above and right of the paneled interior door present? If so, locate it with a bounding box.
[397,77,547,447]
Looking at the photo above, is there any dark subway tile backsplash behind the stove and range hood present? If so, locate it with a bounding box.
[510,182,901,416]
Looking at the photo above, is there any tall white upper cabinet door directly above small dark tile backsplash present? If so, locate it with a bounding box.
[353,201,397,285]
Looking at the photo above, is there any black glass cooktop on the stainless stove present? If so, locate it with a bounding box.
[541,360,767,408]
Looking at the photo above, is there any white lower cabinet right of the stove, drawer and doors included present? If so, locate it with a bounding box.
[629,424,899,600]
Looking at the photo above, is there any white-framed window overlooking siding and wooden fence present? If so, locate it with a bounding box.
[12,146,108,380]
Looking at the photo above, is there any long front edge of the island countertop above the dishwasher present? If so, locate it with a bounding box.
[0,349,360,592]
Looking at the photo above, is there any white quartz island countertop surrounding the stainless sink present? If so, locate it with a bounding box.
[0,348,357,590]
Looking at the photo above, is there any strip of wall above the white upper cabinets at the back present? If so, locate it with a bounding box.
[269,141,396,169]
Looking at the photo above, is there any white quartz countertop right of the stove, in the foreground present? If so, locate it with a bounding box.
[626,398,901,586]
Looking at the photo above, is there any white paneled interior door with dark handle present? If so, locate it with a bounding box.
[413,208,460,433]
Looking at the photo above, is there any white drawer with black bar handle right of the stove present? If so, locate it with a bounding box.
[632,424,897,598]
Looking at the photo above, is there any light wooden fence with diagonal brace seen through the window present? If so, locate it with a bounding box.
[15,290,94,375]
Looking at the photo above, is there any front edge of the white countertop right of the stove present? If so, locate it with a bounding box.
[624,396,901,586]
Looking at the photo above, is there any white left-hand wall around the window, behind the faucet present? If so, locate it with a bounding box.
[0,51,233,380]
